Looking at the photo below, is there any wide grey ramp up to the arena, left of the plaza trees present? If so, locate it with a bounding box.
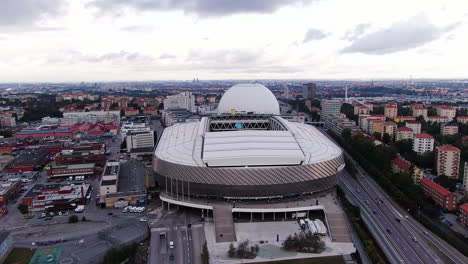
[213,205,236,243]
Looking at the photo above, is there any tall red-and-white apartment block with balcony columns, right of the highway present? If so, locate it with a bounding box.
[435,145,461,179]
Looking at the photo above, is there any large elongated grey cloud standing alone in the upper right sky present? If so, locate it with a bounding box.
[342,15,460,54]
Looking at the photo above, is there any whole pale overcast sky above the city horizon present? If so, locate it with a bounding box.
[0,0,468,82]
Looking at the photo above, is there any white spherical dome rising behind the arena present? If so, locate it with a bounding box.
[218,83,280,115]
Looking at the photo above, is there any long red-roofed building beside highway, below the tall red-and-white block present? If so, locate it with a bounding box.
[421,178,457,211]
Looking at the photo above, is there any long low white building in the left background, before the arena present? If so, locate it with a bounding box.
[61,111,120,125]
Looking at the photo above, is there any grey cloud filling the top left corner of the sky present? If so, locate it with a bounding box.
[0,0,66,26]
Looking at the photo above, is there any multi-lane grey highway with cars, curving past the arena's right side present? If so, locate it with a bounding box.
[323,130,468,264]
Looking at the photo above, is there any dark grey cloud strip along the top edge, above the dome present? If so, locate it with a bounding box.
[88,0,317,16]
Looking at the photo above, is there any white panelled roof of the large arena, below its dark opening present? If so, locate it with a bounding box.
[155,117,341,167]
